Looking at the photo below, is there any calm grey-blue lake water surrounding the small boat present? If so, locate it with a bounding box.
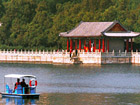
[0,63,140,105]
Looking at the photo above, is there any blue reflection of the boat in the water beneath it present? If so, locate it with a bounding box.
[2,98,39,105]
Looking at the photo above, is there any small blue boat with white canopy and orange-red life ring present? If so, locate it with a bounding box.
[1,74,40,98]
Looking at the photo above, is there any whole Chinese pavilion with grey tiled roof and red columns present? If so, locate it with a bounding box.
[59,21,140,52]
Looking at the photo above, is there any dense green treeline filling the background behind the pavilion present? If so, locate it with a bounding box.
[0,0,140,49]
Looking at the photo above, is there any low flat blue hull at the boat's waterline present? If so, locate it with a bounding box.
[1,93,40,98]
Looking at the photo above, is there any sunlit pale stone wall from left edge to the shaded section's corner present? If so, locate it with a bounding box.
[0,51,101,64]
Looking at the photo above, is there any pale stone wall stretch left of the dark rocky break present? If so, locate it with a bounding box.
[0,51,73,64]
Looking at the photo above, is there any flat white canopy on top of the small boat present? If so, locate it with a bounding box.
[4,74,36,78]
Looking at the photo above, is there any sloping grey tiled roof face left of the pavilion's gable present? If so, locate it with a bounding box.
[60,22,113,37]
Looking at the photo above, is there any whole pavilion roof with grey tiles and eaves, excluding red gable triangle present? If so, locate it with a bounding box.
[59,21,140,37]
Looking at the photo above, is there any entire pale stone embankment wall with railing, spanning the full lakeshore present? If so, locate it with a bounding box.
[0,50,140,64]
